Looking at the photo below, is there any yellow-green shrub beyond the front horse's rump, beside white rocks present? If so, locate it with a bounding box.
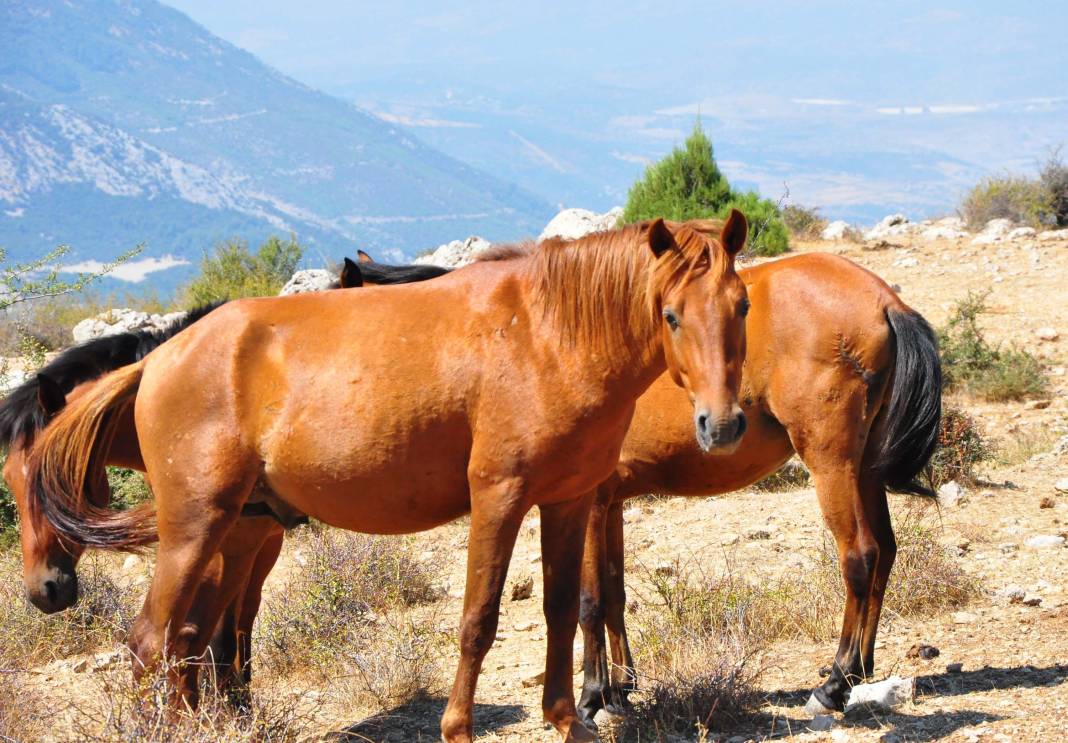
[183,237,303,306]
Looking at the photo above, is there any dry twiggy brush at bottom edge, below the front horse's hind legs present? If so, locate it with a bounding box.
[74,662,318,743]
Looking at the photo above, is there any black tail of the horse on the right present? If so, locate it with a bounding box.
[875,310,942,496]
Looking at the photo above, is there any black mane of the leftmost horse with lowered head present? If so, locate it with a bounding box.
[0,302,223,447]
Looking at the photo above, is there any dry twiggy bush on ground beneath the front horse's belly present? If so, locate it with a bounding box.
[255,528,444,706]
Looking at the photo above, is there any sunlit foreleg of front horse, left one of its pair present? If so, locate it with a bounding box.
[441,486,525,743]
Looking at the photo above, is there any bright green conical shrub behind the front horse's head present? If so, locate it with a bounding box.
[623,122,789,255]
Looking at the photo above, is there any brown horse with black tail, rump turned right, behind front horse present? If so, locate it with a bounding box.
[579,254,941,721]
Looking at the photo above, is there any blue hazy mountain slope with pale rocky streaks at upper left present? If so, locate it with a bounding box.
[0,0,553,275]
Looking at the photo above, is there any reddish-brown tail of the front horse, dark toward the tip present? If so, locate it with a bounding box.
[27,361,158,551]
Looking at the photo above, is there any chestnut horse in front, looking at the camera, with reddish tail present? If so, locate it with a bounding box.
[27,212,748,741]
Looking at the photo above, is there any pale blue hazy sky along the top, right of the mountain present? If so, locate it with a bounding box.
[170,0,1068,106]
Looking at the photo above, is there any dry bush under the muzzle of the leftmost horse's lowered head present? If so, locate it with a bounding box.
[0,550,141,663]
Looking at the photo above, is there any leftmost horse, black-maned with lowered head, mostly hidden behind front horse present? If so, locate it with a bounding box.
[0,257,447,699]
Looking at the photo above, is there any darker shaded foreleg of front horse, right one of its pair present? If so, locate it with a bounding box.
[539,491,597,741]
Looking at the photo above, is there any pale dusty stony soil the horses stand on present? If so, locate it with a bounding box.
[8,233,1068,742]
